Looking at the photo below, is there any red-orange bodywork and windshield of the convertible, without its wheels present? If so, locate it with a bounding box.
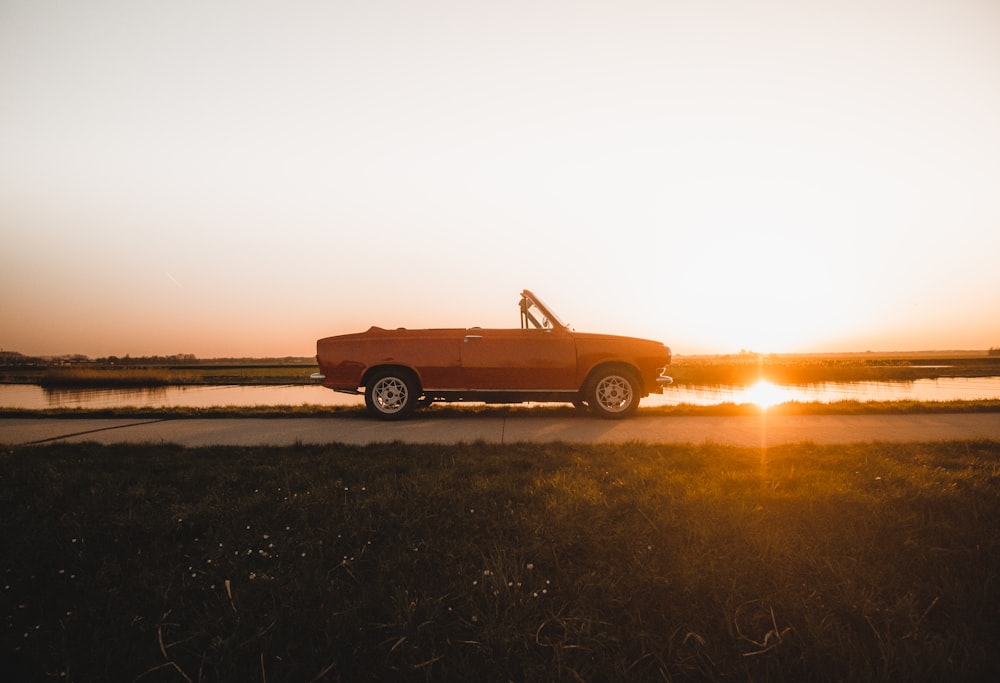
[316,290,671,412]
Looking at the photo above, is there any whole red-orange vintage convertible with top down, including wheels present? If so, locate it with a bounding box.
[313,290,672,420]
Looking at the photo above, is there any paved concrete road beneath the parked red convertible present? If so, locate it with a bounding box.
[0,413,1000,447]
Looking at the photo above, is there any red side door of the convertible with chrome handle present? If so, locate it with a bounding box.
[461,328,578,391]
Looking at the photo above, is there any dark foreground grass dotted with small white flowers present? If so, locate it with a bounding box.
[0,442,1000,681]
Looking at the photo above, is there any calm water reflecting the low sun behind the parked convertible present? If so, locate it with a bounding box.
[0,377,1000,410]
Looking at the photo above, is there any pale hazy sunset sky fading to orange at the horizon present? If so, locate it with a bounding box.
[0,0,1000,357]
